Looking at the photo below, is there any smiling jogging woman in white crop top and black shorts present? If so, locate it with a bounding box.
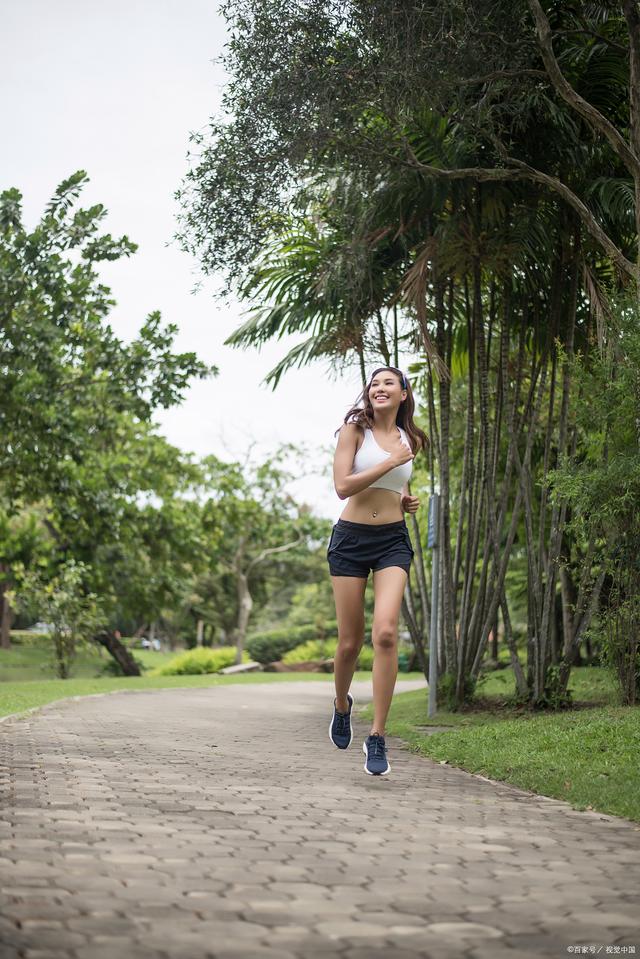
[327,366,428,776]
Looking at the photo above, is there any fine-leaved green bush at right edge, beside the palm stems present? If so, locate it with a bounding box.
[550,299,640,705]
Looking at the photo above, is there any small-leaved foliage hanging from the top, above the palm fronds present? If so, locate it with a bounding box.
[178,0,533,288]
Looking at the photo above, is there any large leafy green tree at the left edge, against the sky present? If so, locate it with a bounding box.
[0,171,218,671]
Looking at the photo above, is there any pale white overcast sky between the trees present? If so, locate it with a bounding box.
[0,0,420,522]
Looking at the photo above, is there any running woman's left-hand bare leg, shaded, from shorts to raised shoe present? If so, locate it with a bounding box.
[331,576,367,713]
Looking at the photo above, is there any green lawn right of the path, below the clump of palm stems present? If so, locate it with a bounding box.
[358,667,640,822]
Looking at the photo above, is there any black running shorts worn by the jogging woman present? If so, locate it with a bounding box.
[327,519,414,579]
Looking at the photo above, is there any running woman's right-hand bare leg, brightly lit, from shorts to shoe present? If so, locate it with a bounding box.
[371,566,407,736]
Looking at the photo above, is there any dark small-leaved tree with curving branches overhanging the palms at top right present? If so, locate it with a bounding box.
[177,0,640,290]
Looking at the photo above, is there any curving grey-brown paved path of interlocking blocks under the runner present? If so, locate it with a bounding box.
[0,681,640,959]
